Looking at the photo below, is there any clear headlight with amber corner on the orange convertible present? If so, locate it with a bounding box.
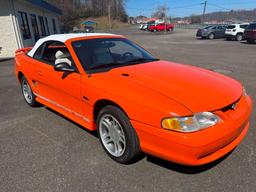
[162,112,221,132]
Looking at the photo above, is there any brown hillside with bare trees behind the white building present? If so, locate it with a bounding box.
[50,0,128,32]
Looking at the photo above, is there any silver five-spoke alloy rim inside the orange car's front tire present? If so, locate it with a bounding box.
[99,114,126,157]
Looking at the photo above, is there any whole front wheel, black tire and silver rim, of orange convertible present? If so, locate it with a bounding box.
[97,105,140,164]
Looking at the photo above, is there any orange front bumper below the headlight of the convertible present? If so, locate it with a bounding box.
[131,96,252,166]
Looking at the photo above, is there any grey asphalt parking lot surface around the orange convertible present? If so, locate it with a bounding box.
[0,29,256,192]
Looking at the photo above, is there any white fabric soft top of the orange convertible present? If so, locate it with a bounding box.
[28,33,121,57]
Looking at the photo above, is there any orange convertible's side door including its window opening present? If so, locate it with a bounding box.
[31,41,82,115]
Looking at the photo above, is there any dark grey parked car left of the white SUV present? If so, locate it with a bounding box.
[196,25,227,39]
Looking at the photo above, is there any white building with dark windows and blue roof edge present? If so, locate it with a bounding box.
[0,0,61,58]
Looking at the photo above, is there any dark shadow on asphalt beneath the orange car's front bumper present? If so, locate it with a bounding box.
[146,149,235,175]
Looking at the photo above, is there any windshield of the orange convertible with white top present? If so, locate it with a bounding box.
[72,38,158,71]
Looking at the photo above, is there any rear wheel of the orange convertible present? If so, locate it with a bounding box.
[20,76,39,107]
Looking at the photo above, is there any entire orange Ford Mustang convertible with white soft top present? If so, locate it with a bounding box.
[15,33,252,166]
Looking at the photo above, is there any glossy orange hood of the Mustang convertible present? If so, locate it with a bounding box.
[104,61,242,113]
